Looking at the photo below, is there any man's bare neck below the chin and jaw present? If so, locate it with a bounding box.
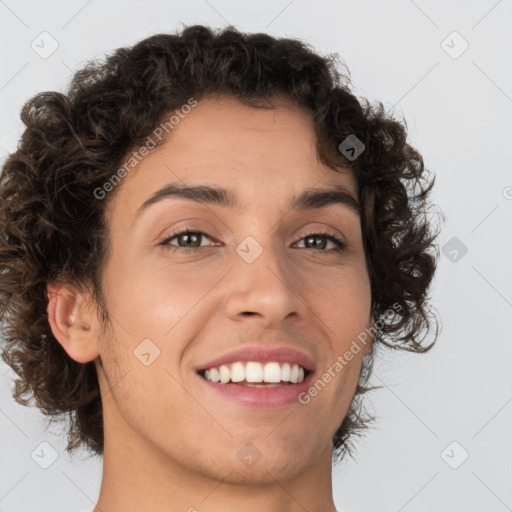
[94,424,336,512]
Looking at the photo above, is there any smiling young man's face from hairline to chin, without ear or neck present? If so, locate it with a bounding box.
[59,99,371,483]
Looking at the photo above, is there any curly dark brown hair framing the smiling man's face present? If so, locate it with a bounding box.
[0,25,439,464]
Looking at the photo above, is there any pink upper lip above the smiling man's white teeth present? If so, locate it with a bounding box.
[196,345,315,371]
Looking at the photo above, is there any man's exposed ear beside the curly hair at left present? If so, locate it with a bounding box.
[47,284,99,363]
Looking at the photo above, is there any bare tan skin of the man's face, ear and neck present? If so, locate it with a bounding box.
[48,97,373,512]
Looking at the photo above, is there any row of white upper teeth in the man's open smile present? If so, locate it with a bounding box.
[204,361,304,384]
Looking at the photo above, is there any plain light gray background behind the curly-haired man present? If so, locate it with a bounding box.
[0,0,512,512]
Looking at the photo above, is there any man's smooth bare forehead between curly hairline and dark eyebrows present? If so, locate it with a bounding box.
[106,98,357,224]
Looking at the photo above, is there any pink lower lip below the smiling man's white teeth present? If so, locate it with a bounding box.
[196,372,314,409]
